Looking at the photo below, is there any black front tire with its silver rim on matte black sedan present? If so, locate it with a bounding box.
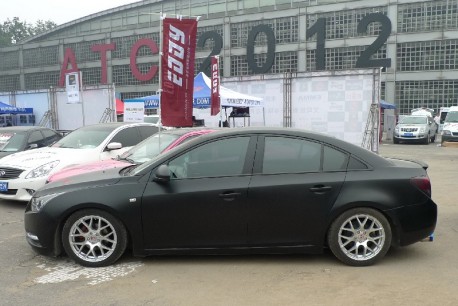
[62,209,127,267]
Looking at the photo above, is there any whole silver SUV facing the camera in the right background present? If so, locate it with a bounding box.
[393,115,437,144]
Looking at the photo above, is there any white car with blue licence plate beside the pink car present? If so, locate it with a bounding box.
[0,122,158,201]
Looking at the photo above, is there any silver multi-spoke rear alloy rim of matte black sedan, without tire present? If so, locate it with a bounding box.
[338,214,385,261]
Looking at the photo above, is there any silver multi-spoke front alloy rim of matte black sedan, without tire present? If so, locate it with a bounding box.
[68,215,118,262]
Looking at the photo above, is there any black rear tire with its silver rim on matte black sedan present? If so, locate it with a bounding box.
[328,207,392,267]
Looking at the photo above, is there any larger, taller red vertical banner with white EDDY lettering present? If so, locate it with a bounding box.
[161,18,197,127]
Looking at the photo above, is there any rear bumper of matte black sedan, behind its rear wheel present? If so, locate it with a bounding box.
[387,199,437,246]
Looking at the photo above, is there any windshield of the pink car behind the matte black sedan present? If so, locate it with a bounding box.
[120,133,180,164]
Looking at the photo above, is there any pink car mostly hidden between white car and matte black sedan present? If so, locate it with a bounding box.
[47,128,216,183]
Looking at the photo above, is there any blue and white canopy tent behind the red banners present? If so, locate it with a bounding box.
[124,72,263,109]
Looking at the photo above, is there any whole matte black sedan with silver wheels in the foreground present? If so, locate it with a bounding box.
[25,128,437,267]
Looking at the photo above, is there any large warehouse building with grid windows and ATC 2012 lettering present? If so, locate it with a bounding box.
[0,0,458,114]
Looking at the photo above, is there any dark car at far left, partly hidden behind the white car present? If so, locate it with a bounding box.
[0,126,62,158]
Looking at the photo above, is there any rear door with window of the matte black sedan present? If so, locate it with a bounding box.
[248,136,348,246]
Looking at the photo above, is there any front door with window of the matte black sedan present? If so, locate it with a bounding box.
[142,137,252,249]
